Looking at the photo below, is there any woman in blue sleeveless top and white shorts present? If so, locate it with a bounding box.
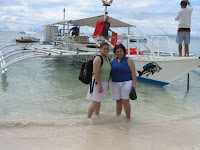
[111,44,137,119]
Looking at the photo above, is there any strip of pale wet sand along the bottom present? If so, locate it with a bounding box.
[0,119,200,150]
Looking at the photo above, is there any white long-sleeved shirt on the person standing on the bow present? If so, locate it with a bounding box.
[175,5,193,28]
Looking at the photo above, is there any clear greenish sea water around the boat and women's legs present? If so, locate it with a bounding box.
[0,32,200,128]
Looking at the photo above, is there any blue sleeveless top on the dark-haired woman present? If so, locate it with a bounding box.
[111,57,132,82]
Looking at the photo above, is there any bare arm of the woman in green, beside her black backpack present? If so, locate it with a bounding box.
[93,56,103,93]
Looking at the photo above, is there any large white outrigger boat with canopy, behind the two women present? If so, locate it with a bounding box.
[0,1,200,86]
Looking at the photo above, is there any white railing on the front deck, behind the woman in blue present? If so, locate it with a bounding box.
[127,35,173,57]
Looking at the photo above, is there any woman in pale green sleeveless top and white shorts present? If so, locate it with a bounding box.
[87,42,111,118]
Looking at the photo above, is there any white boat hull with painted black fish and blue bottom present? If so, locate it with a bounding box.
[131,56,200,86]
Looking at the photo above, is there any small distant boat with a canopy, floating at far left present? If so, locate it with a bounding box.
[15,31,40,43]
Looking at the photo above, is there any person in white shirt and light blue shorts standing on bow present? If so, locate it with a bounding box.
[175,0,193,56]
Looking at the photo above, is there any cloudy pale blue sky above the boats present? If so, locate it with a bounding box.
[0,0,200,37]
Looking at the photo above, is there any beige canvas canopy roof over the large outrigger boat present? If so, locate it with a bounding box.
[51,15,135,28]
